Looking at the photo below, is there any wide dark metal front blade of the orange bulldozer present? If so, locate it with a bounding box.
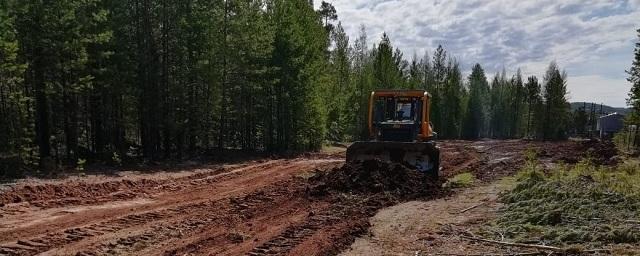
[347,141,440,175]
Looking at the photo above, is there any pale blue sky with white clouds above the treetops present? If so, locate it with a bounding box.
[314,0,640,107]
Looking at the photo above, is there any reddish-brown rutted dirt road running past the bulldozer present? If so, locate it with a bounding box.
[0,141,600,255]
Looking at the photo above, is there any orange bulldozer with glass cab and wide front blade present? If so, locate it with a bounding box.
[347,90,440,177]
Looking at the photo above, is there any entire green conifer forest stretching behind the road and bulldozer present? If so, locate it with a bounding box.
[0,0,576,170]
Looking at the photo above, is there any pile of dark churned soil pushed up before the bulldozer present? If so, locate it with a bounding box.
[308,160,442,199]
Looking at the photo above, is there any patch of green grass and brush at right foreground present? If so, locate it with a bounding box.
[482,154,640,247]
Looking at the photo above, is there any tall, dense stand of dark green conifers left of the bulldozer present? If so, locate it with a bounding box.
[0,0,330,173]
